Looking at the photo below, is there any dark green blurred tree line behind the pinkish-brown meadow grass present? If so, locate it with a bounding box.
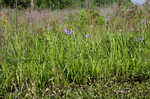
[0,0,118,9]
